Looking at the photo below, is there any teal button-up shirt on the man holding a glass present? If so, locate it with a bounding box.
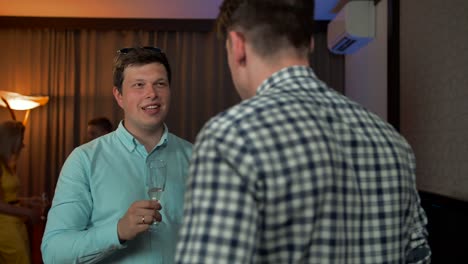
[41,122,192,264]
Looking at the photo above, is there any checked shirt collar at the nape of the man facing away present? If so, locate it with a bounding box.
[257,66,317,95]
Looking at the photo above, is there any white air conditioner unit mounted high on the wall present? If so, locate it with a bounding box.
[327,0,375,54]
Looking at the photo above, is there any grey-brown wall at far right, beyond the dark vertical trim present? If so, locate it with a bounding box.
[400,0,468,201]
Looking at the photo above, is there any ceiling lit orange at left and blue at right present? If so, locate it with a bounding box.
[0,0,342,20]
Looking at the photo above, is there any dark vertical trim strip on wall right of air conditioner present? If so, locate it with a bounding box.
[387,0,400,131]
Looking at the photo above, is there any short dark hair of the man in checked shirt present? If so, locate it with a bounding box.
[216,0,315,56]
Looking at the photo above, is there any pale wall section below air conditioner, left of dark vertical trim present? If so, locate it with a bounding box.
[345,0,388,120]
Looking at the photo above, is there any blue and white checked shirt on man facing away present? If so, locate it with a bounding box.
[176,66,430,264]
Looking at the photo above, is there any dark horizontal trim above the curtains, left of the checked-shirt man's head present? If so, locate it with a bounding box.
[0,16,215,31]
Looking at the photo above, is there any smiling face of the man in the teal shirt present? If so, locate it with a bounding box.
[114,62,171,134]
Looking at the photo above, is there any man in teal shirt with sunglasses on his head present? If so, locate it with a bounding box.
[41,47,192,263]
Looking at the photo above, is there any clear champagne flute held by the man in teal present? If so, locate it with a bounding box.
[146,159,166,231]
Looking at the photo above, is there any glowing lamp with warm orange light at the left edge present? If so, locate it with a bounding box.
[0,90,49,125]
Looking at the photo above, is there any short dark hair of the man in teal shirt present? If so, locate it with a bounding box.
[113,47,171,93]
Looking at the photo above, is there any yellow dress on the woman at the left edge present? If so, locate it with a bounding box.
[0,166,31,264]
